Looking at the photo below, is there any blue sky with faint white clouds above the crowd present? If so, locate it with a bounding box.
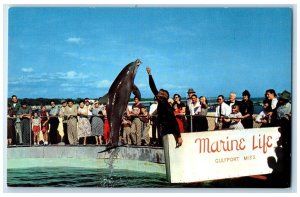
[8,7,292,98]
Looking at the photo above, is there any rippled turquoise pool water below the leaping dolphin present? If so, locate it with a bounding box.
[7,167,169,188]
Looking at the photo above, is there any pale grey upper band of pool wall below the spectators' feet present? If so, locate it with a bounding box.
[7,146,165,164]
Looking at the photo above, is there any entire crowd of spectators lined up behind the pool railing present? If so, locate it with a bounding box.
[7,88,291,146]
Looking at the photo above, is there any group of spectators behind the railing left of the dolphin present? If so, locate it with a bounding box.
[7,95,109,146]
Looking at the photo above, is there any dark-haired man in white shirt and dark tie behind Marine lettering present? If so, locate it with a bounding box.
[215,95,231,130]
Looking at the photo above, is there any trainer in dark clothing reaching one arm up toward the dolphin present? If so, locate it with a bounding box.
[146,67,182,147]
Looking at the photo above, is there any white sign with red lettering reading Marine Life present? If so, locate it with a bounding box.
[163,127,280,183]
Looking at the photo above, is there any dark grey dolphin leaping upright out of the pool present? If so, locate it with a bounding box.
[100,59,142,147]
